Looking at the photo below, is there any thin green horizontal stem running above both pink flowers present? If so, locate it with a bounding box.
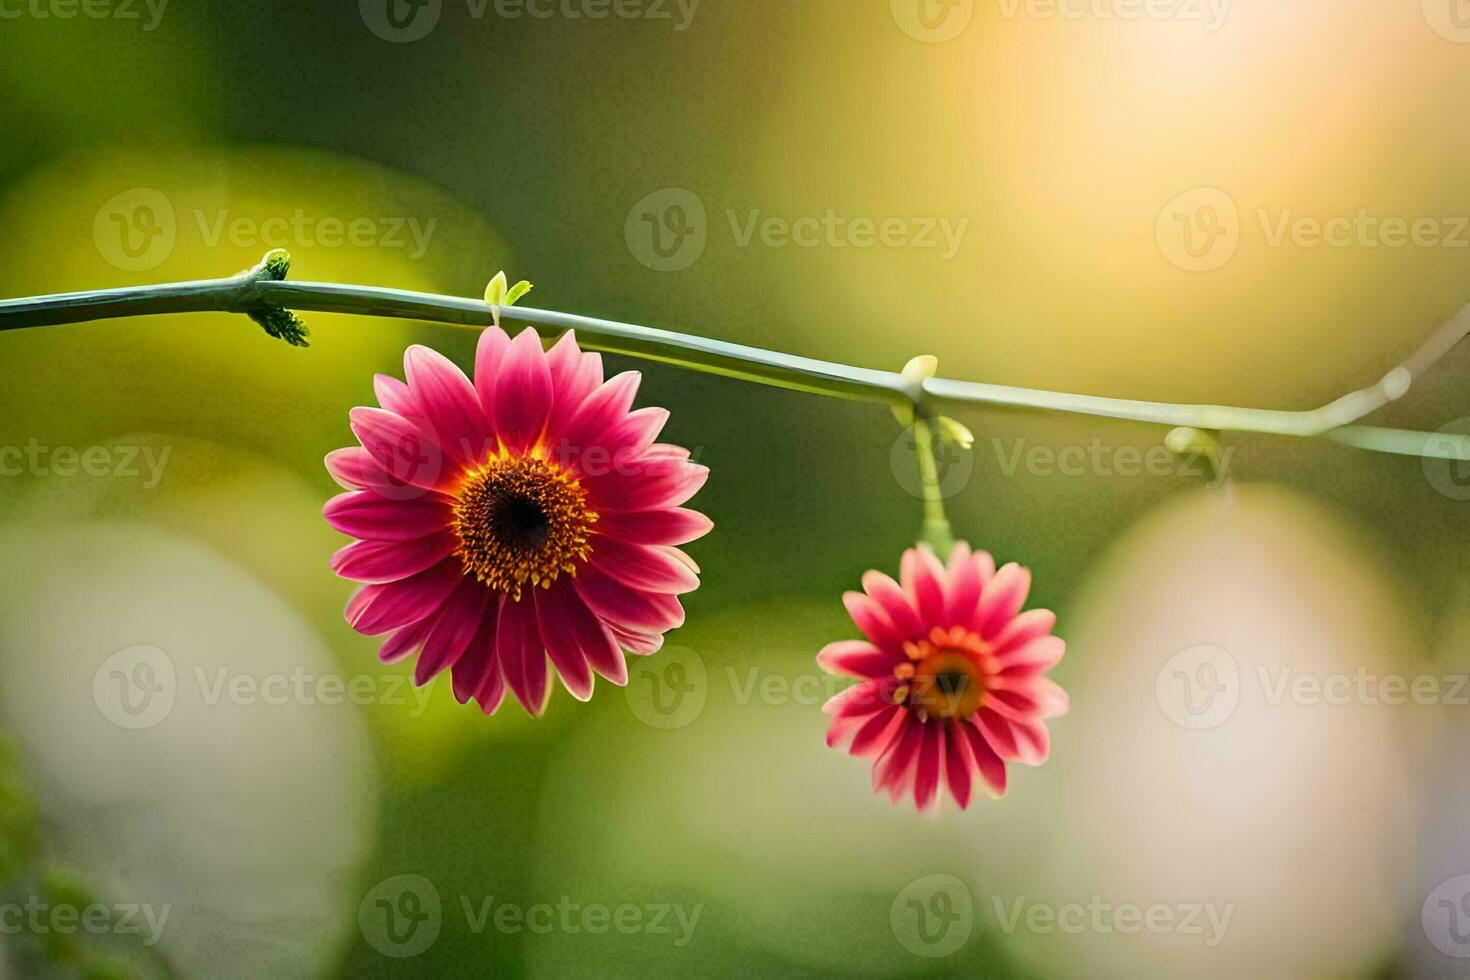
[0,253,1470,460]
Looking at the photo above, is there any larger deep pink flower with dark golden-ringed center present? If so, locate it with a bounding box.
[323,328,710,714]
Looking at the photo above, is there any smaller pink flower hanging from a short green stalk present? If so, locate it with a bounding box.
[817,542,1067,810]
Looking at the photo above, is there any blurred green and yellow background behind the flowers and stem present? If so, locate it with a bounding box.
[0,0,1470,977]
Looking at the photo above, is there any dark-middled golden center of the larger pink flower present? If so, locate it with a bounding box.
[454,454,597,602]
